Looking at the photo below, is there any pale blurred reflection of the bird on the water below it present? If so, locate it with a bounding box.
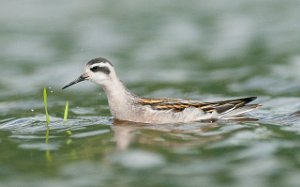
[112,118,257,150]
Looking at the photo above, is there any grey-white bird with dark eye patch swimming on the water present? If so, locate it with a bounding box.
[62,57,261,124]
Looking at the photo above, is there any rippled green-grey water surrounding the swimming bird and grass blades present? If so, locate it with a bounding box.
[0,0,300,187]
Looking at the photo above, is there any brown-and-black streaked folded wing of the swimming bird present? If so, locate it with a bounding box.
[138,97,259,114]
